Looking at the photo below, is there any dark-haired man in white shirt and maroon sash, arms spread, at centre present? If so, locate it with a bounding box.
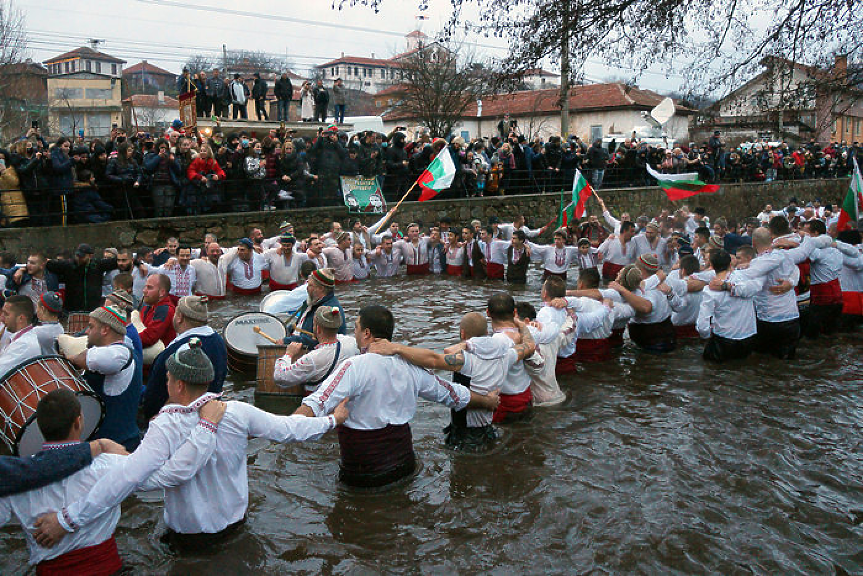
[295,305,498,487]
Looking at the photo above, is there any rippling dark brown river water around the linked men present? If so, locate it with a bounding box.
[0,273,863,575]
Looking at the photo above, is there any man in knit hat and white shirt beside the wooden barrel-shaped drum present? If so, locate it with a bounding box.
[273,306,360,394]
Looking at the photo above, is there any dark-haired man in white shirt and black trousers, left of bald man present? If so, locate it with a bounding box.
[696,250,761,362]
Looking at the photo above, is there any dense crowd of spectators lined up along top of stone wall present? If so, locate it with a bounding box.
[0,119,863,227]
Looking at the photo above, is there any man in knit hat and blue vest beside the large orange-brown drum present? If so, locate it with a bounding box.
[69,306,144,452]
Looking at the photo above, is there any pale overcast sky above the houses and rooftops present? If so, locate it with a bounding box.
[12,0,681,91]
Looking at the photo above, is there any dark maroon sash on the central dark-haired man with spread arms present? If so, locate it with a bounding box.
[338,423,414,486]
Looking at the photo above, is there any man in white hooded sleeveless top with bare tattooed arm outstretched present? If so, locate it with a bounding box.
[369,312,534,451]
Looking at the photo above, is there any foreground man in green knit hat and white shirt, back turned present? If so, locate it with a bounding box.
[37,338,348,550]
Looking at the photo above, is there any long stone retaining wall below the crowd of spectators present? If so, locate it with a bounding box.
[0,179,849,256]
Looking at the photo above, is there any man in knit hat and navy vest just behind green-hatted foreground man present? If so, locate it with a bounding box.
[141,296,228,420]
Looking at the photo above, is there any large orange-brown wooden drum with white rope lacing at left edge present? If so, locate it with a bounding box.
[0,356,105,456]
